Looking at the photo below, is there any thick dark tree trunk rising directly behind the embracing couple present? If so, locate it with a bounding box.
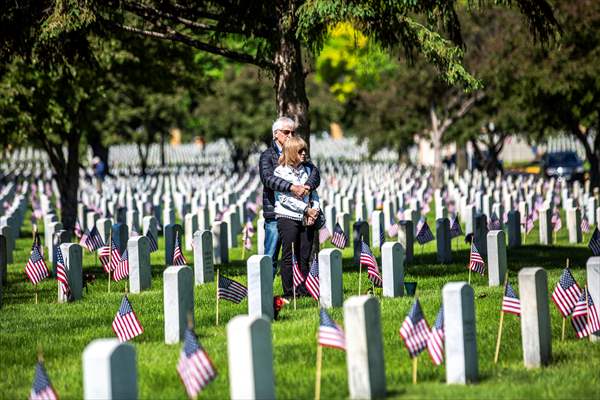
[273,10,310,145]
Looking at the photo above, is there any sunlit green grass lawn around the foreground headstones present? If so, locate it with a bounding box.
[0,211,600,399]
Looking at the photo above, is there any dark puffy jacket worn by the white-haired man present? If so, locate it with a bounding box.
[258,141,321,219]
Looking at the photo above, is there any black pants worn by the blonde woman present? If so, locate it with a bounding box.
[277,218,315,296]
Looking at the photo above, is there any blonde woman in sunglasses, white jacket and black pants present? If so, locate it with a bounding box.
[274,137,319,297]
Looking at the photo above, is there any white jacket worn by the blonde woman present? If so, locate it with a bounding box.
[273,164,319,221]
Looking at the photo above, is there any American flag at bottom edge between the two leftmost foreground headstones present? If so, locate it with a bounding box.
[177,328,217,399]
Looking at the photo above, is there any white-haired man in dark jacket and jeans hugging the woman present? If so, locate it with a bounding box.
[259,117,321,278]
